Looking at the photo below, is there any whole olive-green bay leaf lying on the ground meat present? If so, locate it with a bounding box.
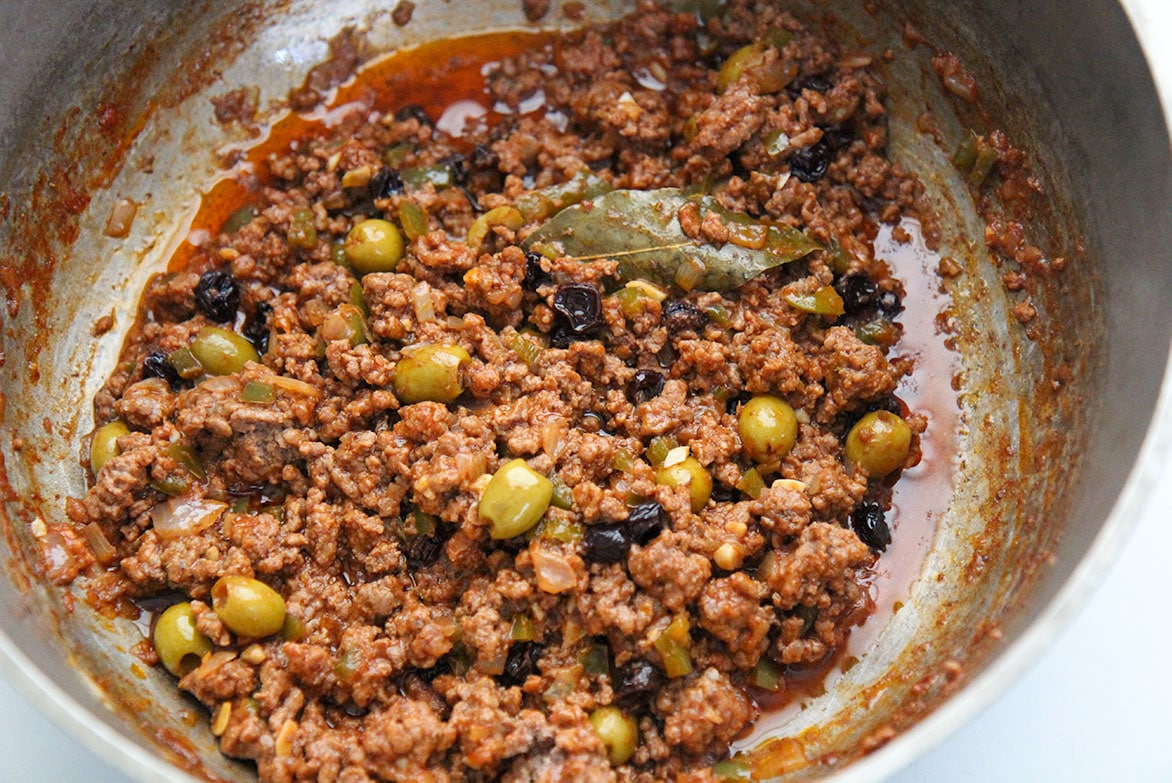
[525,188,820,291]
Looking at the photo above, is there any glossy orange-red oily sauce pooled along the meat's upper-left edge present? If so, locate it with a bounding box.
[168,30,551,272]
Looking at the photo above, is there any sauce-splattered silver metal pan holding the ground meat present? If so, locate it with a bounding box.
[0,0,1172,781]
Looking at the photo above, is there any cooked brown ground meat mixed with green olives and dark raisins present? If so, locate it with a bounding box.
[68,0,928,782]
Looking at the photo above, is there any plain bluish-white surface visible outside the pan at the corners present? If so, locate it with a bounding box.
[0,0,1172,783]
